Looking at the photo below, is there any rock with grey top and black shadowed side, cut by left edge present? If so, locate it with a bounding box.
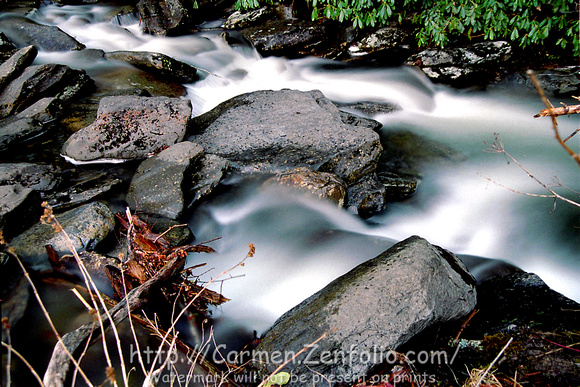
[0,184,42,240]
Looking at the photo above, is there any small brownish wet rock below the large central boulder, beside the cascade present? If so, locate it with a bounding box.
[264,167,346,207]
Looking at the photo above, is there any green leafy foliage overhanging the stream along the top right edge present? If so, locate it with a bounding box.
[236,0,580,56]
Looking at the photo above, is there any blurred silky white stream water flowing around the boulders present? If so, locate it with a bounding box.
[10,0,580,350]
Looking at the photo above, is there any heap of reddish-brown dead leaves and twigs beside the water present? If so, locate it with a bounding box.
[107,212,228,312]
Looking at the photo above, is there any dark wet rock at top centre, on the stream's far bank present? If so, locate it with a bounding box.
[241,20,326,56]
